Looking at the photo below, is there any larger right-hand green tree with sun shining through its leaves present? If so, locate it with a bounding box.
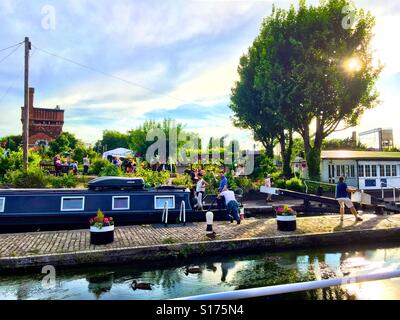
[230,0,381,179]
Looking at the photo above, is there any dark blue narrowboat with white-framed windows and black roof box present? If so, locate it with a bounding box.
[0,177,224,231]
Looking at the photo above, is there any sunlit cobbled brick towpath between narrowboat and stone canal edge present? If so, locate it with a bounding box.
[0,214,400,259]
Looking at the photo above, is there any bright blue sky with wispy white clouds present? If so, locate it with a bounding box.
[0,0,400,148]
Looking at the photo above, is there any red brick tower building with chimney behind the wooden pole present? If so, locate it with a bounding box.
[21,88,64,146]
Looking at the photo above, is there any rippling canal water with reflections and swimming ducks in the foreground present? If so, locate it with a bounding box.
[0,244,400,300]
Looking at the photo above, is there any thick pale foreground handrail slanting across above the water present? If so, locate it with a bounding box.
[173,269,400,300]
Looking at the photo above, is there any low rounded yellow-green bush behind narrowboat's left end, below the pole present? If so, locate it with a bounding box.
[4,168,49,188]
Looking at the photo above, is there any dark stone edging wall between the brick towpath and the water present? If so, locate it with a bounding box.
[0,228,400,272]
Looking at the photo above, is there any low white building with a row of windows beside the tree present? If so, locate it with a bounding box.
[321,150,400,190]
